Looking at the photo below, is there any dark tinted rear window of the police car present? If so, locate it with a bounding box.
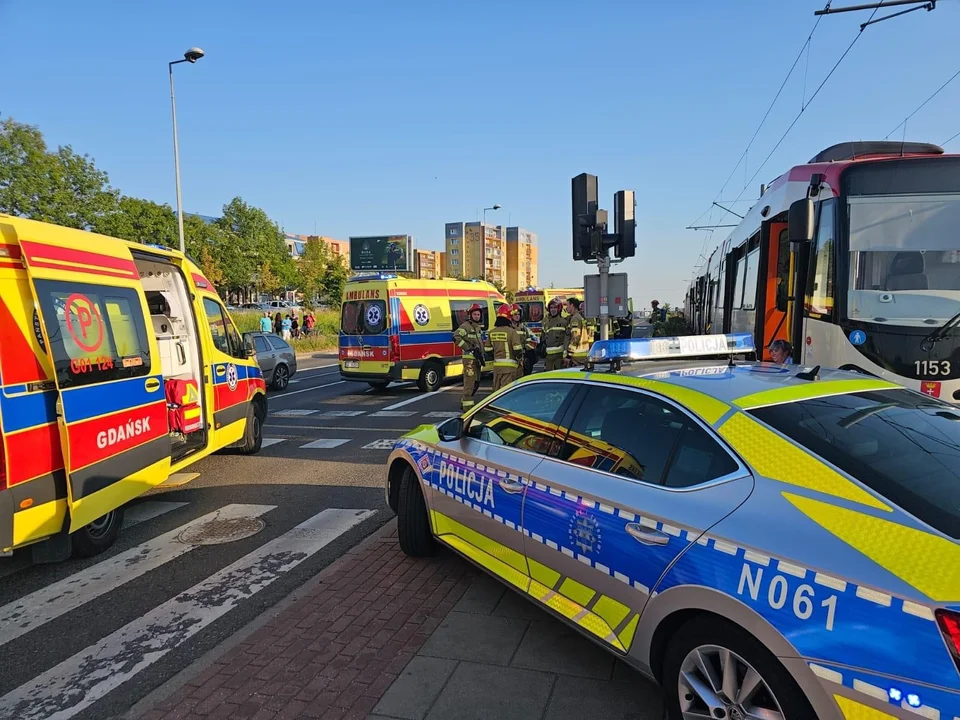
[749,390,960,538]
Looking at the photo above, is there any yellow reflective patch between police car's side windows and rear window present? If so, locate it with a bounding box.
[719,413,892,512]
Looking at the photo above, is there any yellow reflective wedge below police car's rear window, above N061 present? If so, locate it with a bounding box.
[783,493,960,602]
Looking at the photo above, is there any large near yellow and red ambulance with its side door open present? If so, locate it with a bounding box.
[0,214,267,562]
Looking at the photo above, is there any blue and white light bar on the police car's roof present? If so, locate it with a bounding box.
[587,333,756,363]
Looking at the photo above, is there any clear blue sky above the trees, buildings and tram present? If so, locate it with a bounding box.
[0,0,960,304]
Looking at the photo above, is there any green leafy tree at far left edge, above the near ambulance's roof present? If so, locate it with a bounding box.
[0,118,119,229]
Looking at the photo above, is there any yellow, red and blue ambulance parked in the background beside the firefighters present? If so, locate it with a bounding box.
[340,273,506,392]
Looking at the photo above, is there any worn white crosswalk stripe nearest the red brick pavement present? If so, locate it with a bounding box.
[0,508,376,720]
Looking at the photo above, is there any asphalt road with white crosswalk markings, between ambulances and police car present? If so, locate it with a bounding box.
[0,358,480,720]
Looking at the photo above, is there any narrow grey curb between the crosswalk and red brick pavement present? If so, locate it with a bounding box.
[120,512,396,720]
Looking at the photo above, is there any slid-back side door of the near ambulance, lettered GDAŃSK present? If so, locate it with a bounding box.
[19,231,170,532]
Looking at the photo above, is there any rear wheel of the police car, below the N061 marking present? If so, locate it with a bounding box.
[662,616,817,720]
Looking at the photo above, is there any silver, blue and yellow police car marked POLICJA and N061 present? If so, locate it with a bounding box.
[386,334,960,720]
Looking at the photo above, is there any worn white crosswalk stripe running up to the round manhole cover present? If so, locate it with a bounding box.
[0,505,276,648]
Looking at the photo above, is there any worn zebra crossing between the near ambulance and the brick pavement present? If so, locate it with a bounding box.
[0,500,377,720]
